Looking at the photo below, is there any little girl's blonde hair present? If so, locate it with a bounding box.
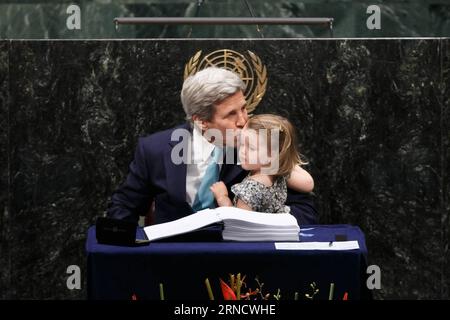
[246,114,307,176]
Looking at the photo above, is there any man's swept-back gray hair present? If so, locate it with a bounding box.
[181,67,245,121]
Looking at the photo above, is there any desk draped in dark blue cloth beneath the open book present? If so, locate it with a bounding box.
[86,225,367,300]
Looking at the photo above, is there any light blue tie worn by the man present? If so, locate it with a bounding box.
[192,147,222,212]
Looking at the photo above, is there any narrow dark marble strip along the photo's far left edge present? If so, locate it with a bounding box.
[0,41,11,299]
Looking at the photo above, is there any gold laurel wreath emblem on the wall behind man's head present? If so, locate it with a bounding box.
[184,49,267,113]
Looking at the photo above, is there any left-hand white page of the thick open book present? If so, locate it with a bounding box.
[144,209,222,241]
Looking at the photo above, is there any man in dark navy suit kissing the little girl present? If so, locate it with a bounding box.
[108,68,317,225]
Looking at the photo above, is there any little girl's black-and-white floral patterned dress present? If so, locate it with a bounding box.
[231,176,291,213]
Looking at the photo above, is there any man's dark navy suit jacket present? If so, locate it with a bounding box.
[108,123,317,225]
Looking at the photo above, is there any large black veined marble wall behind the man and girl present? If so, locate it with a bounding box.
[4,40,449,298]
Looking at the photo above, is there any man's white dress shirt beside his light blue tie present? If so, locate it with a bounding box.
[186,125,221,207]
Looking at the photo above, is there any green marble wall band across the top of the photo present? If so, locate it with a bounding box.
[0,0,450,39]
